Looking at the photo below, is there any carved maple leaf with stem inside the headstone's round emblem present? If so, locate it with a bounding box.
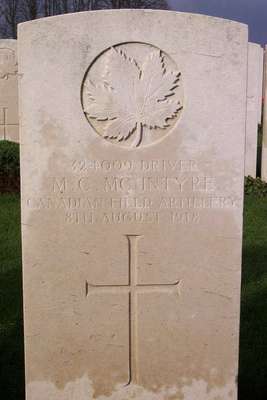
[84,48,182,146]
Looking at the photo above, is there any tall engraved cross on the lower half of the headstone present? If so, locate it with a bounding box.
[85,235,180,385]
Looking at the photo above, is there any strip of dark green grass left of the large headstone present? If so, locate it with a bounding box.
[0,195,24,400]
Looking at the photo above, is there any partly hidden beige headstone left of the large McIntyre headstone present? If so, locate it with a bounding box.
[0,39,19,142]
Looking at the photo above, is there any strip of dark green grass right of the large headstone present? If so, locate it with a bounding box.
[239,196,267,400]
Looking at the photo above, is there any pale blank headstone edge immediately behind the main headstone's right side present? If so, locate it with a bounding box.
[245,43,263,178]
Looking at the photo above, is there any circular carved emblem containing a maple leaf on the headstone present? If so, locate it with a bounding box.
[81,42,183,147]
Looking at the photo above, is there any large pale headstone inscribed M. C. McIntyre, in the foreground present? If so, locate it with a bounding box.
[19,10,248,400]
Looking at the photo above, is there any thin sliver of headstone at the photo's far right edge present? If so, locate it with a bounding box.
[261,46,267,182]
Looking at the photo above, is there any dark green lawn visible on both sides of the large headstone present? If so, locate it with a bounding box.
[0,195,267,400]
